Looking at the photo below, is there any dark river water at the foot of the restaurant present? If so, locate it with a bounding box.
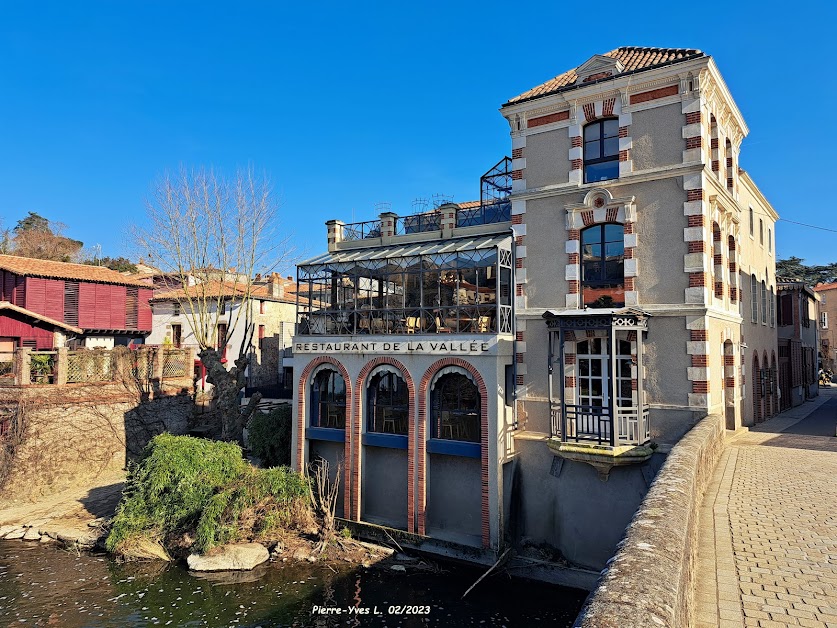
[0,541,586,628]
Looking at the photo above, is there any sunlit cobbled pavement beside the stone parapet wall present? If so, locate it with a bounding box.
[695,387,837,628]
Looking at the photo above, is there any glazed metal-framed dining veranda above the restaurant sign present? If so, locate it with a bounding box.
[297,234,514,336]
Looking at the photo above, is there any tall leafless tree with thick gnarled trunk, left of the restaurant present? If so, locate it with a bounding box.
[134,168,292,440]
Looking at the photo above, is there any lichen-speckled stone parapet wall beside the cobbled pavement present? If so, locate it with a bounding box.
[575,415,725,628]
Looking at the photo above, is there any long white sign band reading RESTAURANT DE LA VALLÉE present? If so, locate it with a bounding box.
[294,339,497,355]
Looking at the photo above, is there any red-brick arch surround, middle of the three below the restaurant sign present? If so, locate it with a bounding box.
[346,356,416,533]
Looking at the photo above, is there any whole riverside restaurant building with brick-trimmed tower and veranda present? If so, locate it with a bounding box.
[294,48,778,568]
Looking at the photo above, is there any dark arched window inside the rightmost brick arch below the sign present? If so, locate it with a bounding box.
[430,373,481,443]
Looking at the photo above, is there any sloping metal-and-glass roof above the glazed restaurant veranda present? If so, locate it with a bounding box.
[298,234,511,266]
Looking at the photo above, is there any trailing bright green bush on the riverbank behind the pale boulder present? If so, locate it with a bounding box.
[106,434,311,556]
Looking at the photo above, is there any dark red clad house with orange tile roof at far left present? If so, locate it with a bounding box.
[0,255,154,353]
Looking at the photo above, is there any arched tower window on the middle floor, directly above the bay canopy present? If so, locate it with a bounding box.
[581,223,625,307]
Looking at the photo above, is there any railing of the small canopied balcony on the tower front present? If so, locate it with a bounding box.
[550,403,651,446]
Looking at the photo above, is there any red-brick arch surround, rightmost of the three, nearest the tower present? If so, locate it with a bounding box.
[416,358,491,548]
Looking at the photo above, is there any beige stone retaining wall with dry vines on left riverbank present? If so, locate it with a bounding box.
[0,379,193,501]
